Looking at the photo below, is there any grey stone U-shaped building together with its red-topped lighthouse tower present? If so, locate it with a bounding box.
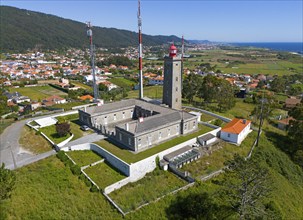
[79,45,198,152]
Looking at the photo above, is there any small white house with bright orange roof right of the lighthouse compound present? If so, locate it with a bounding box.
[220,118,251,144]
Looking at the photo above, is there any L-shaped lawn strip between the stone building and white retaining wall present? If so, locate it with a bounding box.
[95,126,212,163]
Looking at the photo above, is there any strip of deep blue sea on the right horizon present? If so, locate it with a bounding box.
[232,42,303,54]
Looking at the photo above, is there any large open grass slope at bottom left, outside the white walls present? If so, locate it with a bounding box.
[0,156,122,220]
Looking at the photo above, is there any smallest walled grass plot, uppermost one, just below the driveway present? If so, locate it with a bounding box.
[66,150,102,167]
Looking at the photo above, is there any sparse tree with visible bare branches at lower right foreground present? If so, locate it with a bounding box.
[221,154,270,219]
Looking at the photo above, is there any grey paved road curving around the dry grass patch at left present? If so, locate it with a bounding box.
[0,111,75,169]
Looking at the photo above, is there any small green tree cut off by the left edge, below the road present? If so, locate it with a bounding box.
[0,163,16,202]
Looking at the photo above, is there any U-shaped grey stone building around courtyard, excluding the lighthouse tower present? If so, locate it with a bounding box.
[79,99,198,152]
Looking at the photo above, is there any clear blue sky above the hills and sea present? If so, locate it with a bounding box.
[1,0,303,42]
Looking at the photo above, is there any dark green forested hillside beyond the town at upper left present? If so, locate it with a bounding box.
[0,6,181,51]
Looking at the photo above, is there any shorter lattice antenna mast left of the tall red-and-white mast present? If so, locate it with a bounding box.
[86,22,99,103]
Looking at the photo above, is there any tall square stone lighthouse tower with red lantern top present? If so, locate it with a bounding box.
[163,44,182,110]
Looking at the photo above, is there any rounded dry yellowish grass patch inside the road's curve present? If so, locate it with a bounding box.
[19,126,52,154]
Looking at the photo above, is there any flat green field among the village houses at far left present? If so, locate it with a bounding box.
[9,86,67,101]
